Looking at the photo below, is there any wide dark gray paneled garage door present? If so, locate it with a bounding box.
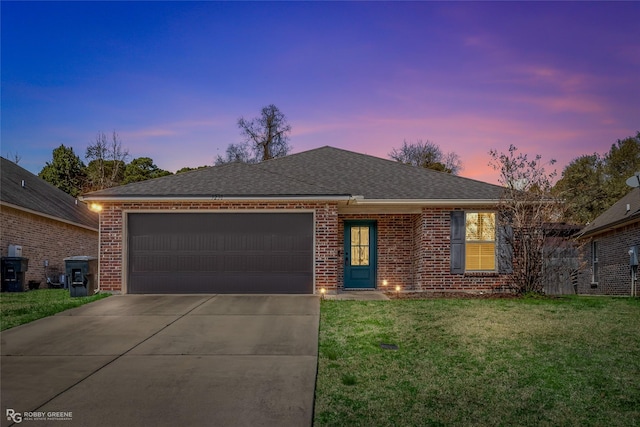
[128,213,313,294]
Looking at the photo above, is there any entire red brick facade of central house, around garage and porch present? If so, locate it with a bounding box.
[95,201,504,292]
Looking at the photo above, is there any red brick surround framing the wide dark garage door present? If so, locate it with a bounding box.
[100,201,340,293]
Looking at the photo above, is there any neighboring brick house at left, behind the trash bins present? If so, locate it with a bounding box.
[0,158,98,288]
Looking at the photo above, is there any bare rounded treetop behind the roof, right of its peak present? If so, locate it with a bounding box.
[389,139,462,175]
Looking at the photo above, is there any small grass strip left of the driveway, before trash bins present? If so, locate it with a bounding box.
[0,289,109,331]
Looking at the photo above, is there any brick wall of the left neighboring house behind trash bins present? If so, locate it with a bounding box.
[0,206,98,288]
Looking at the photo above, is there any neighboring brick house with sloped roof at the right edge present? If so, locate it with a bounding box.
[578,188,640,295]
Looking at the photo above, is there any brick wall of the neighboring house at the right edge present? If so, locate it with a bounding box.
[578,222,640,295]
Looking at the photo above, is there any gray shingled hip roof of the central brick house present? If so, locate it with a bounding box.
[85,147,502,201]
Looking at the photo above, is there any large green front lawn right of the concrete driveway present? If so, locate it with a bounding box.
[314,297,640,426]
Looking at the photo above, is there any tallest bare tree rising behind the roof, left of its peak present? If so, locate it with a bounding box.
[215,104,291,165]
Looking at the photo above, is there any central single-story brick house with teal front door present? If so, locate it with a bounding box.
[83,147,510,293]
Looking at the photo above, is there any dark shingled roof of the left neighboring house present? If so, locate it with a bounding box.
[0,157,98,230]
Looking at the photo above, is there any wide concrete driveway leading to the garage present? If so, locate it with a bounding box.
[0,295,320,427]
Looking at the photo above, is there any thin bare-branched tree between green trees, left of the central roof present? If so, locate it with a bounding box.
[85,131,129,191]
